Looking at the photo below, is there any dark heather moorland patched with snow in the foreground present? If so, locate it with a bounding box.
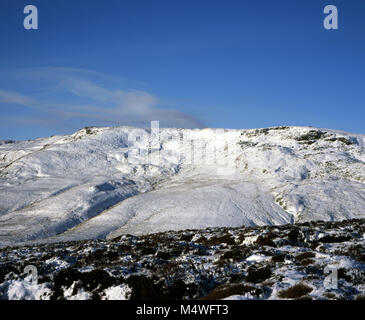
[0,219,365,300]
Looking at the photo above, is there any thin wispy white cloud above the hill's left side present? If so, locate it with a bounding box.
[0,68,204,128]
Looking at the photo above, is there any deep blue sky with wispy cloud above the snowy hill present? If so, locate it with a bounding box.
[0,0,365,139]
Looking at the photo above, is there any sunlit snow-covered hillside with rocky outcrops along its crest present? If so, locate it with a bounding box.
[0,127,365,245]
